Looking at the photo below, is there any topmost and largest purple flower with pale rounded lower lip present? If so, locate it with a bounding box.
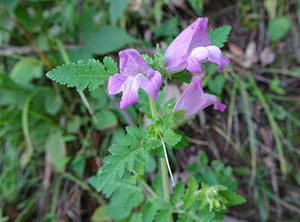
[164,18,230,74]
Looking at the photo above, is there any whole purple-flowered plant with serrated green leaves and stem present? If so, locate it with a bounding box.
[47,18,246,222]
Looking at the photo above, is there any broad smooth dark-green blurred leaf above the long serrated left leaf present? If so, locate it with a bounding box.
[87,26,136,55]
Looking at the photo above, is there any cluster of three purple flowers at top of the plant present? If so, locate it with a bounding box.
[108,18,230,118]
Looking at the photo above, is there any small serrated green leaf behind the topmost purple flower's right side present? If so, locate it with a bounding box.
[208,25,231,48]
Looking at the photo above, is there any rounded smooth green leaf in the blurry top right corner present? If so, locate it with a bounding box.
[268,17,292,42]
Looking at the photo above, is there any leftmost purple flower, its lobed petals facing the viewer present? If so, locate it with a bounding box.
[108,49,162,109]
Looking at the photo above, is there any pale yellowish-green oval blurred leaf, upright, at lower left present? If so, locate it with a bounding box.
[45,132,67,172]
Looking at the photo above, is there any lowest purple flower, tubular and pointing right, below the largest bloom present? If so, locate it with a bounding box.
[173,76,226,119]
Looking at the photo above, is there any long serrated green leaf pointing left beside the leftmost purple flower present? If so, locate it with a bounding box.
[46,59,116,91]
